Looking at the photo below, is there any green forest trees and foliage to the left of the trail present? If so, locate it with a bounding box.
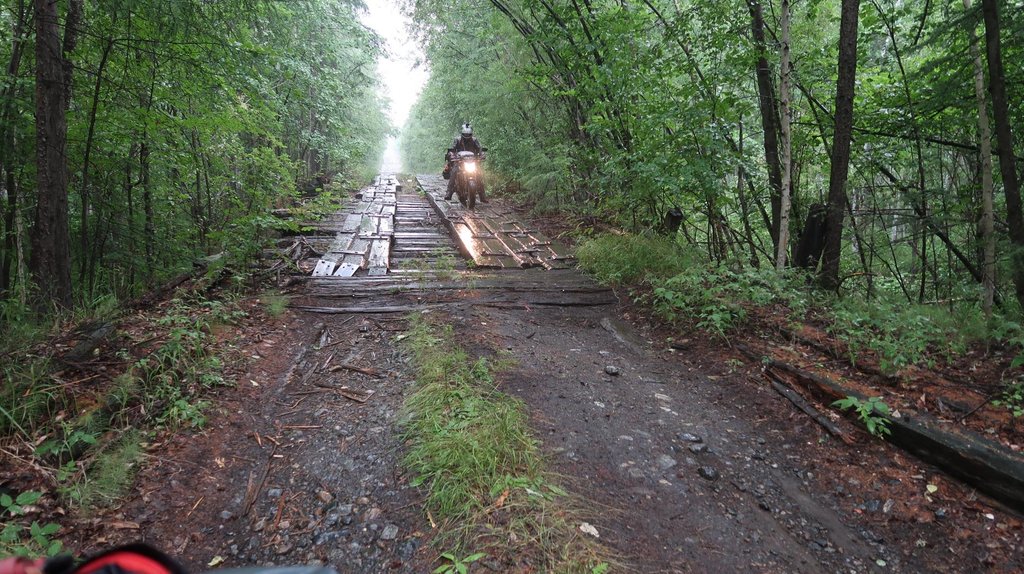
[0,0,391,308]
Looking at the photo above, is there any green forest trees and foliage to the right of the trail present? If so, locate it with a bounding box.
[402,0,1024,310]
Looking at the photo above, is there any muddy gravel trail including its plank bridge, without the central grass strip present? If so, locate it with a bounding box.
[73,178,1024,573]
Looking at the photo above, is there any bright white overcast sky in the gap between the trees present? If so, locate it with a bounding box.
[362,0,428,128]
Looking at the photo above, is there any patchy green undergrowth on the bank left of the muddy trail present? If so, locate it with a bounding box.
[0,296,246,555]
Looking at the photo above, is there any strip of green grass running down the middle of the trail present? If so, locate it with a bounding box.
[401,315,609,572]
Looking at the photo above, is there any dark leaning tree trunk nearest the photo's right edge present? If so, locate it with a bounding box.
[981,0,1024,306]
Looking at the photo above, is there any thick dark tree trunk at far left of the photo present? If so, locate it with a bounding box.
[30,0,81,311]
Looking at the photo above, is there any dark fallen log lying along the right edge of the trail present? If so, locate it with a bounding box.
[736,345,1024,513]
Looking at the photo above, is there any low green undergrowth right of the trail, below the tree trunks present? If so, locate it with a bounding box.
[578,230,1024,376]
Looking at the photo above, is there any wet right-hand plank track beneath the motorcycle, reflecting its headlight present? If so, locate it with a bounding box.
[417,175,575,269]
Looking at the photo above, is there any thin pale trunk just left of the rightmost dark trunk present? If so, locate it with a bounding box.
[964,0,995,317]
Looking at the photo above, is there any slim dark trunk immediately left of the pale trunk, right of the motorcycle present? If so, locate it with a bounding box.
[746,0,782,253]
